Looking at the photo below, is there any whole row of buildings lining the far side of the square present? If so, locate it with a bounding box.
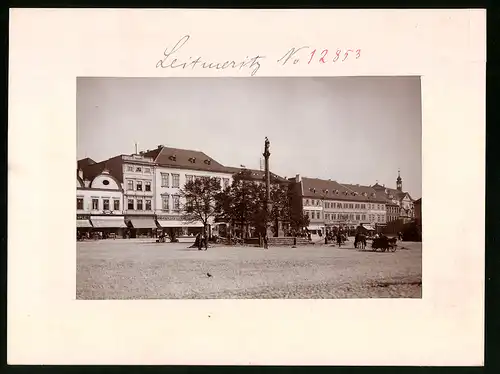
[76,145,415,237]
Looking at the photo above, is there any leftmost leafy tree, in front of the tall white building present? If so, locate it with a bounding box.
[180,177,221,234]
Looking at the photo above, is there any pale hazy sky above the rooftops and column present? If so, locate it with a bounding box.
[77,77,422,198]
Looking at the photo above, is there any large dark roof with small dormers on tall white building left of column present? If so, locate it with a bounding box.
[142,146,228,173]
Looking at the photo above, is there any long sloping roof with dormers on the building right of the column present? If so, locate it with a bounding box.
[302,178,386,203]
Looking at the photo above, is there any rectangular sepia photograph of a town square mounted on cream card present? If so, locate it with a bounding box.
[75,76,422,300]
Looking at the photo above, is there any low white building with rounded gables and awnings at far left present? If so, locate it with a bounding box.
[76,164,126,236]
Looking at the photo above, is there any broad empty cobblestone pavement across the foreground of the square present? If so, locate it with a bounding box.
[76,240,422,299]
